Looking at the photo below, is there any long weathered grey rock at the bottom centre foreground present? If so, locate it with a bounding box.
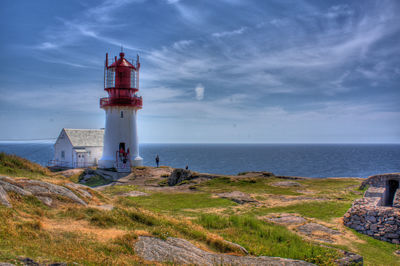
[135,236,314,265]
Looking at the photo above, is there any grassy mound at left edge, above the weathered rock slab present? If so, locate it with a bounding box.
[0,152,51,178]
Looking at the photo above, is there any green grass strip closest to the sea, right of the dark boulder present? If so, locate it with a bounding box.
[196,177,301,195]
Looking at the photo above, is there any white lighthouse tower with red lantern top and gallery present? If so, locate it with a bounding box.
[98,52,143,172]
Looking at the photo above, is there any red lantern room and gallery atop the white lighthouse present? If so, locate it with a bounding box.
[100,52,142,109]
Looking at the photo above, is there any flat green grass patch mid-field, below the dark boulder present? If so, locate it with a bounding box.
[119,193,237,212]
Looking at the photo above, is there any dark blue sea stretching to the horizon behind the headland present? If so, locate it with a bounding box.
[0,142,400,178]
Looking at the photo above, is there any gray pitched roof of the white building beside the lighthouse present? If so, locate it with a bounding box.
[63,128,104,147]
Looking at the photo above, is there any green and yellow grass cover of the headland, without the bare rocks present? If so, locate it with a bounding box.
[0,154,400,265]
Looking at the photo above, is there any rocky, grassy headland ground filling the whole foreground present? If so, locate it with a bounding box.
[0,155,400,265]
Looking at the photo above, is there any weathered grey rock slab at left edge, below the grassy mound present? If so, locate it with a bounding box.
[0,177,87,207]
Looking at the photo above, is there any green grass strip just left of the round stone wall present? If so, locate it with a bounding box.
[249,201,351,221]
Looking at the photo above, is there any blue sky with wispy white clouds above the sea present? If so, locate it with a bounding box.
[0,0,400,143]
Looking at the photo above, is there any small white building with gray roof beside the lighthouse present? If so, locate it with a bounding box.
[50,128,104,168]
